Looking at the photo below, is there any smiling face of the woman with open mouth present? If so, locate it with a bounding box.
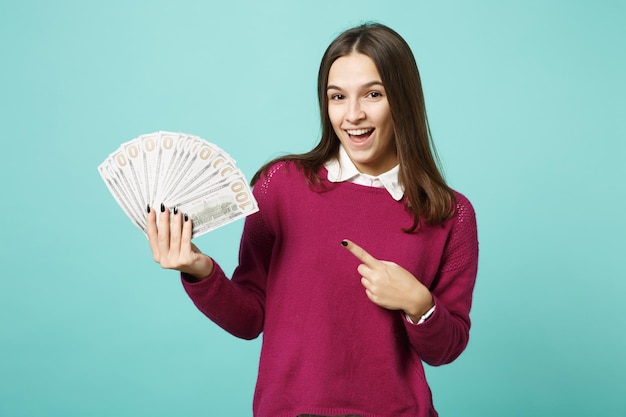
[326,53,398,175]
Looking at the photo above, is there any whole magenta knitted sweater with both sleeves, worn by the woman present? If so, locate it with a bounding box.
[183,162,478,417]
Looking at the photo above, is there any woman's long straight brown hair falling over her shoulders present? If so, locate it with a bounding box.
[251,23,456,232]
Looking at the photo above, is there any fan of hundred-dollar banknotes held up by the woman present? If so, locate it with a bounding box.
[98,132,258,237]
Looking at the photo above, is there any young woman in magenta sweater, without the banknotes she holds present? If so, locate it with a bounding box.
[147,24,478,417]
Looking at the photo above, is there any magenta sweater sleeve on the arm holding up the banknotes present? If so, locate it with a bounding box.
[182,172,274,339]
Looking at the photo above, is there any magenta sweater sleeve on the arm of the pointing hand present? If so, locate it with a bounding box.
[405,195,478,366]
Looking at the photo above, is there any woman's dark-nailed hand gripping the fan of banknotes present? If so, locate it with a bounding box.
[146,204,213,281]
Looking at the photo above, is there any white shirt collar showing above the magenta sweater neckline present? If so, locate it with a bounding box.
[324,145,404,201]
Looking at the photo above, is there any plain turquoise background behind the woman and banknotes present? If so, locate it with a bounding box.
[0,0,626,417]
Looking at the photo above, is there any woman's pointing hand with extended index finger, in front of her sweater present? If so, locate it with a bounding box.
[341,240,434,323]
